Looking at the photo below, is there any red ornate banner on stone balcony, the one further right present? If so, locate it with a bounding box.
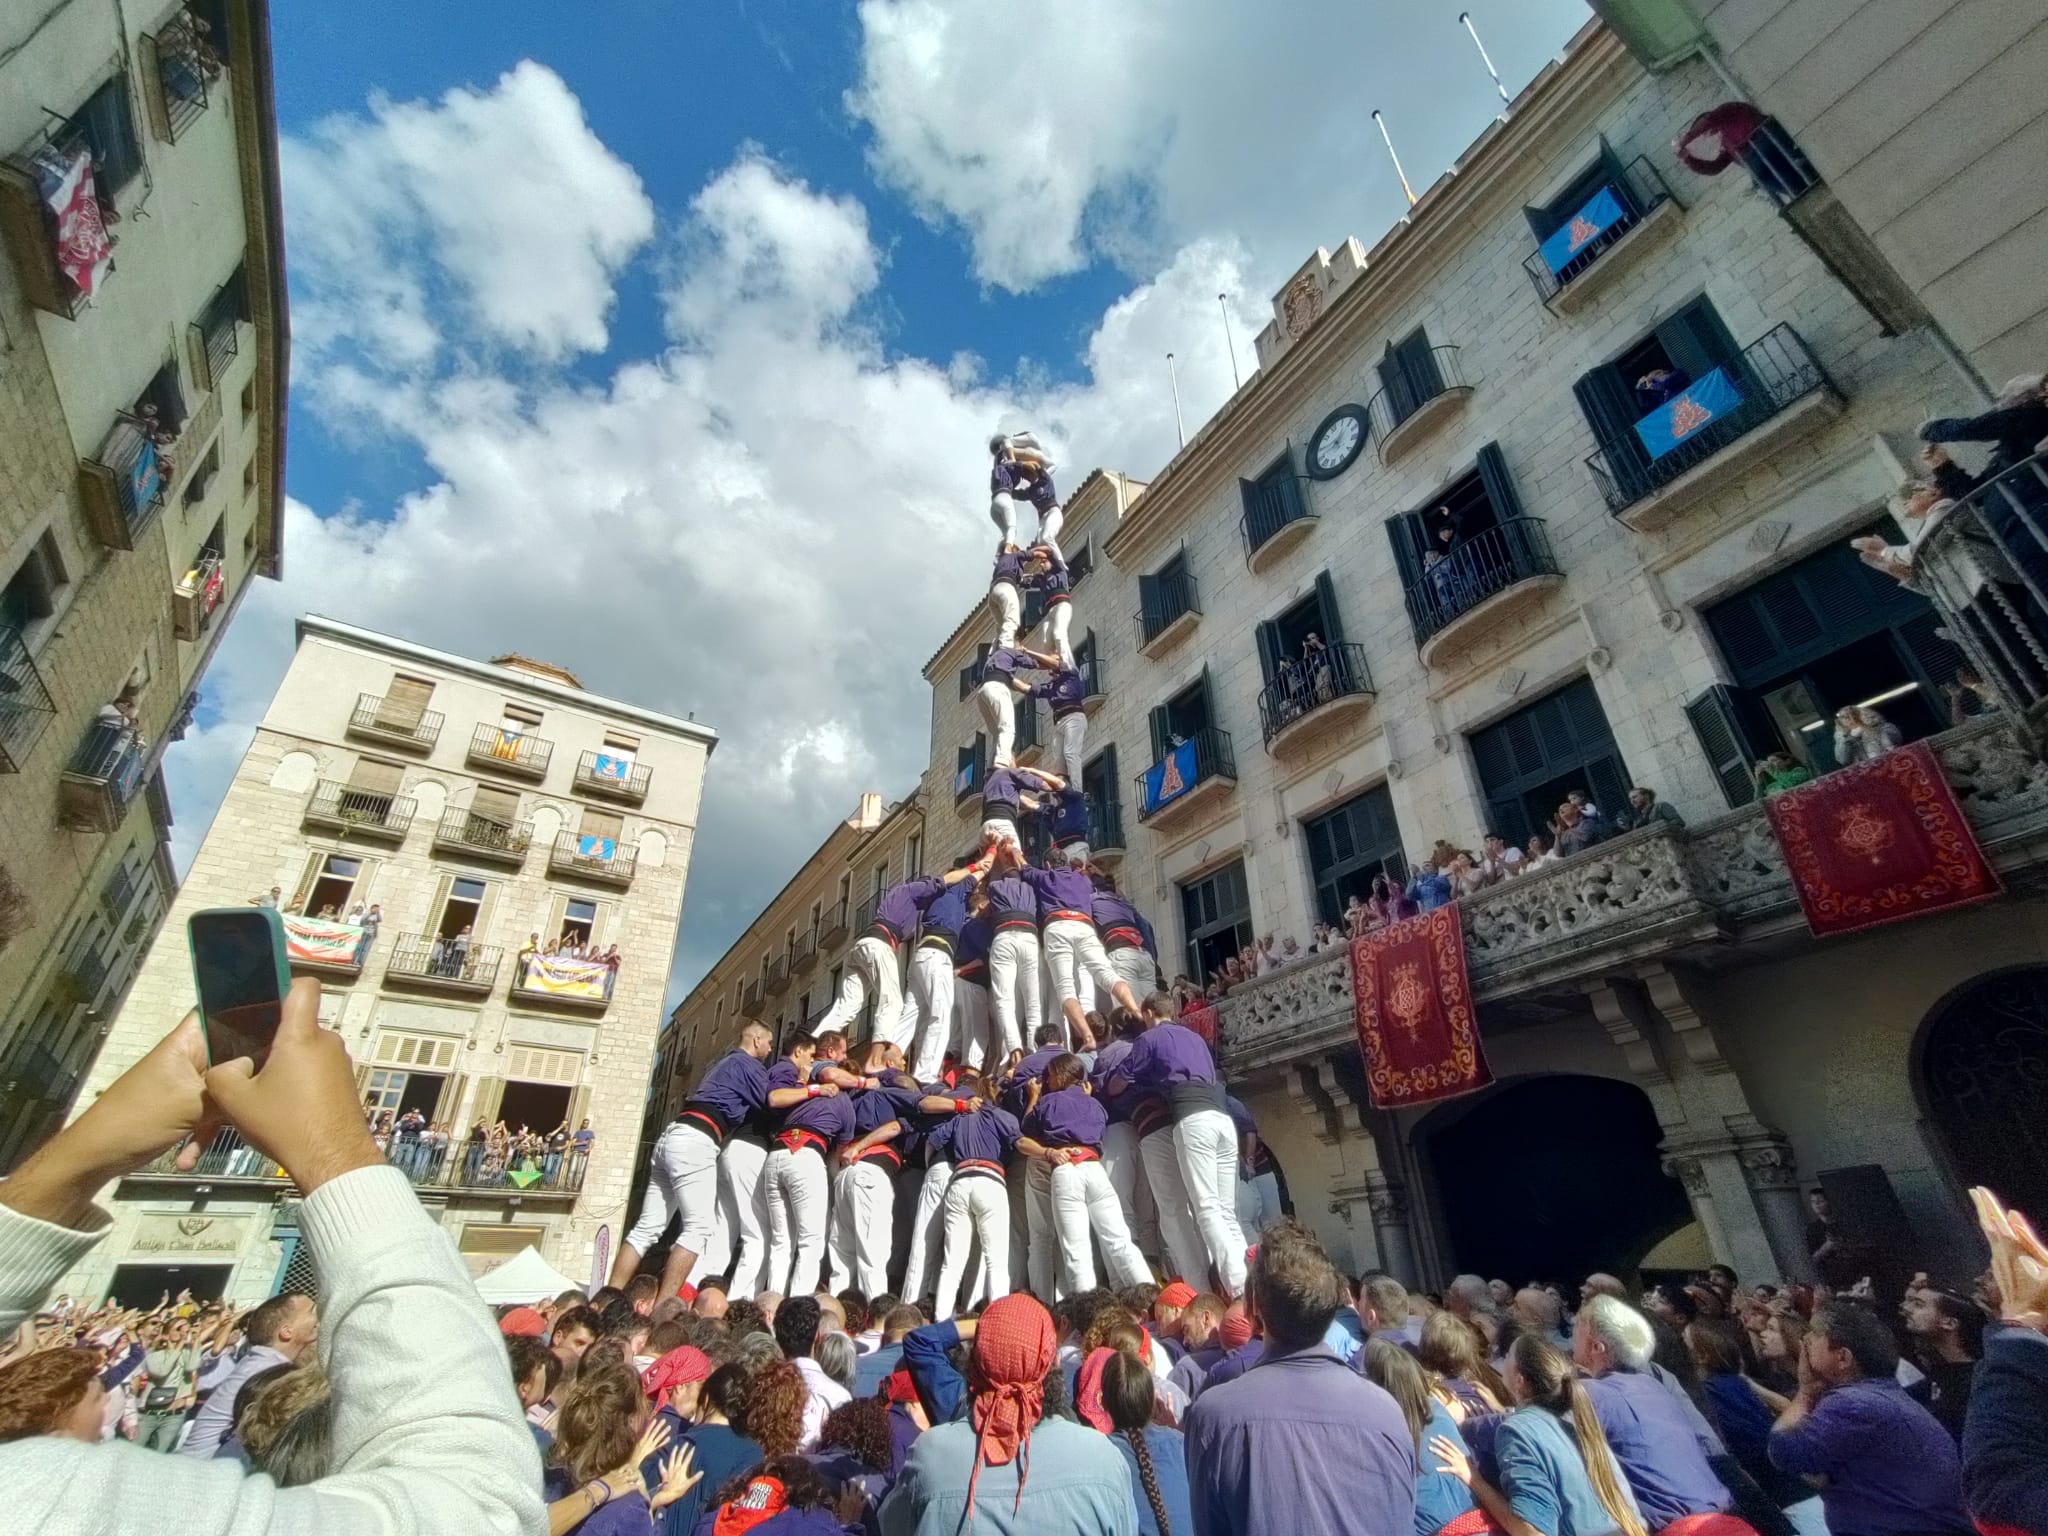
[1763,741,2001,938]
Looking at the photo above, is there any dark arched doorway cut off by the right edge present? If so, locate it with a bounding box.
[1915,965,2048,1219]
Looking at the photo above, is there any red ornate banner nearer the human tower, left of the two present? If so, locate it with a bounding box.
[1352,903,1493,1110]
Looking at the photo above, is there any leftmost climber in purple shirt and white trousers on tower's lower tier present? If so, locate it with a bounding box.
[610,1024,774,1296]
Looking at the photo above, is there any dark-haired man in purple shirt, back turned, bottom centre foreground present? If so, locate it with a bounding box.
[1184,1221,1417,1536]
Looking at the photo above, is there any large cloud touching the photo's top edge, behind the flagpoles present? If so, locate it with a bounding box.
[848,0,1587,291]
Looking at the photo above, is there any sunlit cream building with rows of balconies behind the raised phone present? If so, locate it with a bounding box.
[68,618,717,1300]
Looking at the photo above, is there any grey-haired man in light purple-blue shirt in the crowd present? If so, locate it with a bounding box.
[1572,1292,1735,1532]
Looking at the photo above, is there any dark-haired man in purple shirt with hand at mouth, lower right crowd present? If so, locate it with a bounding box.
[1769,1300,1974,1536]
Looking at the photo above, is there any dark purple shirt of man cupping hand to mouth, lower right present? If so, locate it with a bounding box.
[1769,1378,1972,1536]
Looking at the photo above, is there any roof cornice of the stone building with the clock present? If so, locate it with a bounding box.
[1102,18,1640,565]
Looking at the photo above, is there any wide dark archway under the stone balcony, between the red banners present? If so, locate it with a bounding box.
[1415,1075,1692,1284]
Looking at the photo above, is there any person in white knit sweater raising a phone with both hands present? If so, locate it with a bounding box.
[0,978,547,1536]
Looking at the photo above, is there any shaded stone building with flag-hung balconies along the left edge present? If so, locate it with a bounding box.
[0,0,287,1167]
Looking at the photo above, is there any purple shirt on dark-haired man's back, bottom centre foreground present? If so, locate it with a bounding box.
[1186,1346,1415,1536]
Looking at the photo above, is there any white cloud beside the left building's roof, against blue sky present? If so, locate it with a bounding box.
[283,61,653,367]
